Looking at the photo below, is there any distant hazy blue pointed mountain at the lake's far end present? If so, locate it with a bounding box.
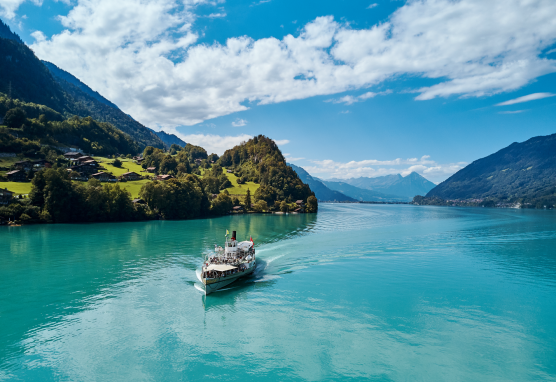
[331,172,436,199]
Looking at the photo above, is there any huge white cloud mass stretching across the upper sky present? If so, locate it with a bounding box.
[29,0,556,128]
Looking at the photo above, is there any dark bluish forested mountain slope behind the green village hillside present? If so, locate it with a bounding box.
[0,23,164,148]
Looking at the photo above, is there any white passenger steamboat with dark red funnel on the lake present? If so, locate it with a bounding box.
[201,231,256,294]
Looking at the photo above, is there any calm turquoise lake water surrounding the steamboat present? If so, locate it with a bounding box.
[0,204,556,381]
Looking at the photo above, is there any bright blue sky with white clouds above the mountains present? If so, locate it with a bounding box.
[0,0,556,183]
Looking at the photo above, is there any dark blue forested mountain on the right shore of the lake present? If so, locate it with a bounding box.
[426,134,556,200]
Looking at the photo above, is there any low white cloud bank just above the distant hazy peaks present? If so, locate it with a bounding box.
[303,155,467,182]
